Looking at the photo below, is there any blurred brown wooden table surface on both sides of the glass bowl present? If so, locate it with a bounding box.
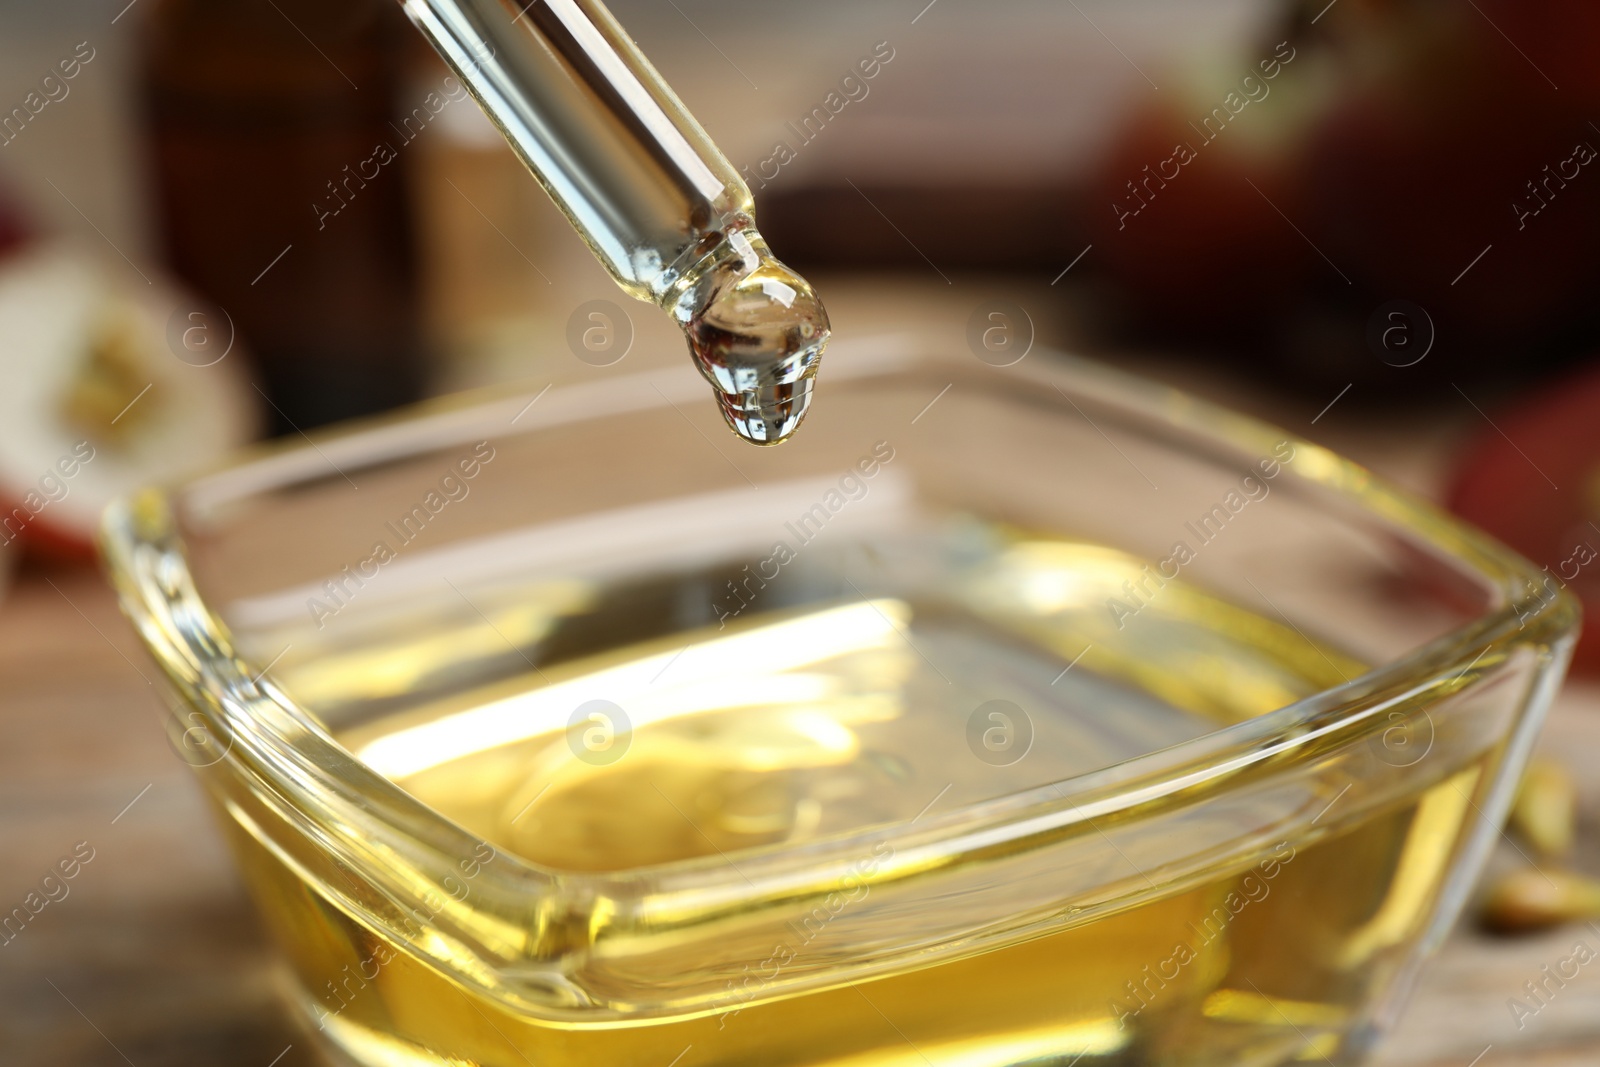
[0,556,1600,1067]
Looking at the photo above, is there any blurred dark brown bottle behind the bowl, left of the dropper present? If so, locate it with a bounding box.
[144,0,422,434]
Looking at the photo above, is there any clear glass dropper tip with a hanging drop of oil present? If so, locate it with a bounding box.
[403,0,829,445]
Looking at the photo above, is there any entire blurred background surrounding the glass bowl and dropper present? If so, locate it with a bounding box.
[0,0,1600,1067]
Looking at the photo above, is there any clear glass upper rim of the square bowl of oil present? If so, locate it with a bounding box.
[101,334,1579,907]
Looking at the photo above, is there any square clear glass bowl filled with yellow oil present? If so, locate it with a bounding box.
[104,341,1578,1067]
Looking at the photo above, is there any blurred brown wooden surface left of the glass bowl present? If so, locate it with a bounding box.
[0,571,320,1067]
